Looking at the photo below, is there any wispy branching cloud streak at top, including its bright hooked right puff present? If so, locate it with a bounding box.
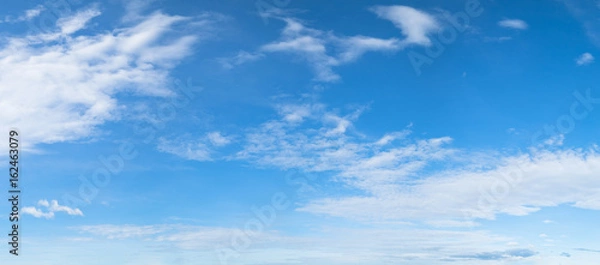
[220,5,440,82]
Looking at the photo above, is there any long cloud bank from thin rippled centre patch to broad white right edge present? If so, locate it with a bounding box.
[225,99,600,225]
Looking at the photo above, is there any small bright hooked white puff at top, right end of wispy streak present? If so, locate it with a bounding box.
[371,6,440,46]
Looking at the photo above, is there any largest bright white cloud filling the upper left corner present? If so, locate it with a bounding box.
[0,9,220,148]
